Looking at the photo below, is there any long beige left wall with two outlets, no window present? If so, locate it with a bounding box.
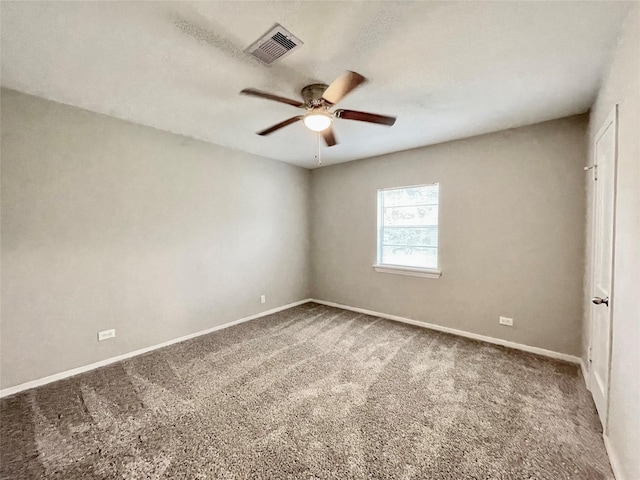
[1,90,309,388]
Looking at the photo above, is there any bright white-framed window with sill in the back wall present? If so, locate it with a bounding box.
[374,183,440,278]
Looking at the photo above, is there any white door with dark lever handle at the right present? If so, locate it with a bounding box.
[590,105,618,433]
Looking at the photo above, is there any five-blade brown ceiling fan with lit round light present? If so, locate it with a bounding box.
[240,71,396,147]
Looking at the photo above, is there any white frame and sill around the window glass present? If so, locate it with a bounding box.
[373,182,442,278]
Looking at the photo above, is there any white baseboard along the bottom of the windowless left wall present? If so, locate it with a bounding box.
[0,298,311,398]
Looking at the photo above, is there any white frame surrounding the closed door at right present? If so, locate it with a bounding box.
[585,104,619,436]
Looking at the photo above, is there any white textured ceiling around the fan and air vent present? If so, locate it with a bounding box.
[0,1,630,168]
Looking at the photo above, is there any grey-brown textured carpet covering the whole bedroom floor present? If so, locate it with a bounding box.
[0,303,613,480]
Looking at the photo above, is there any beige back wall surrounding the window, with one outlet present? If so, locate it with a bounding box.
[311,116,587,355]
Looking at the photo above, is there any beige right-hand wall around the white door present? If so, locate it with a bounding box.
[583,4,640,479]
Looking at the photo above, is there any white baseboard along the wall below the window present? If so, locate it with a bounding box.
[311,298,580,364]
